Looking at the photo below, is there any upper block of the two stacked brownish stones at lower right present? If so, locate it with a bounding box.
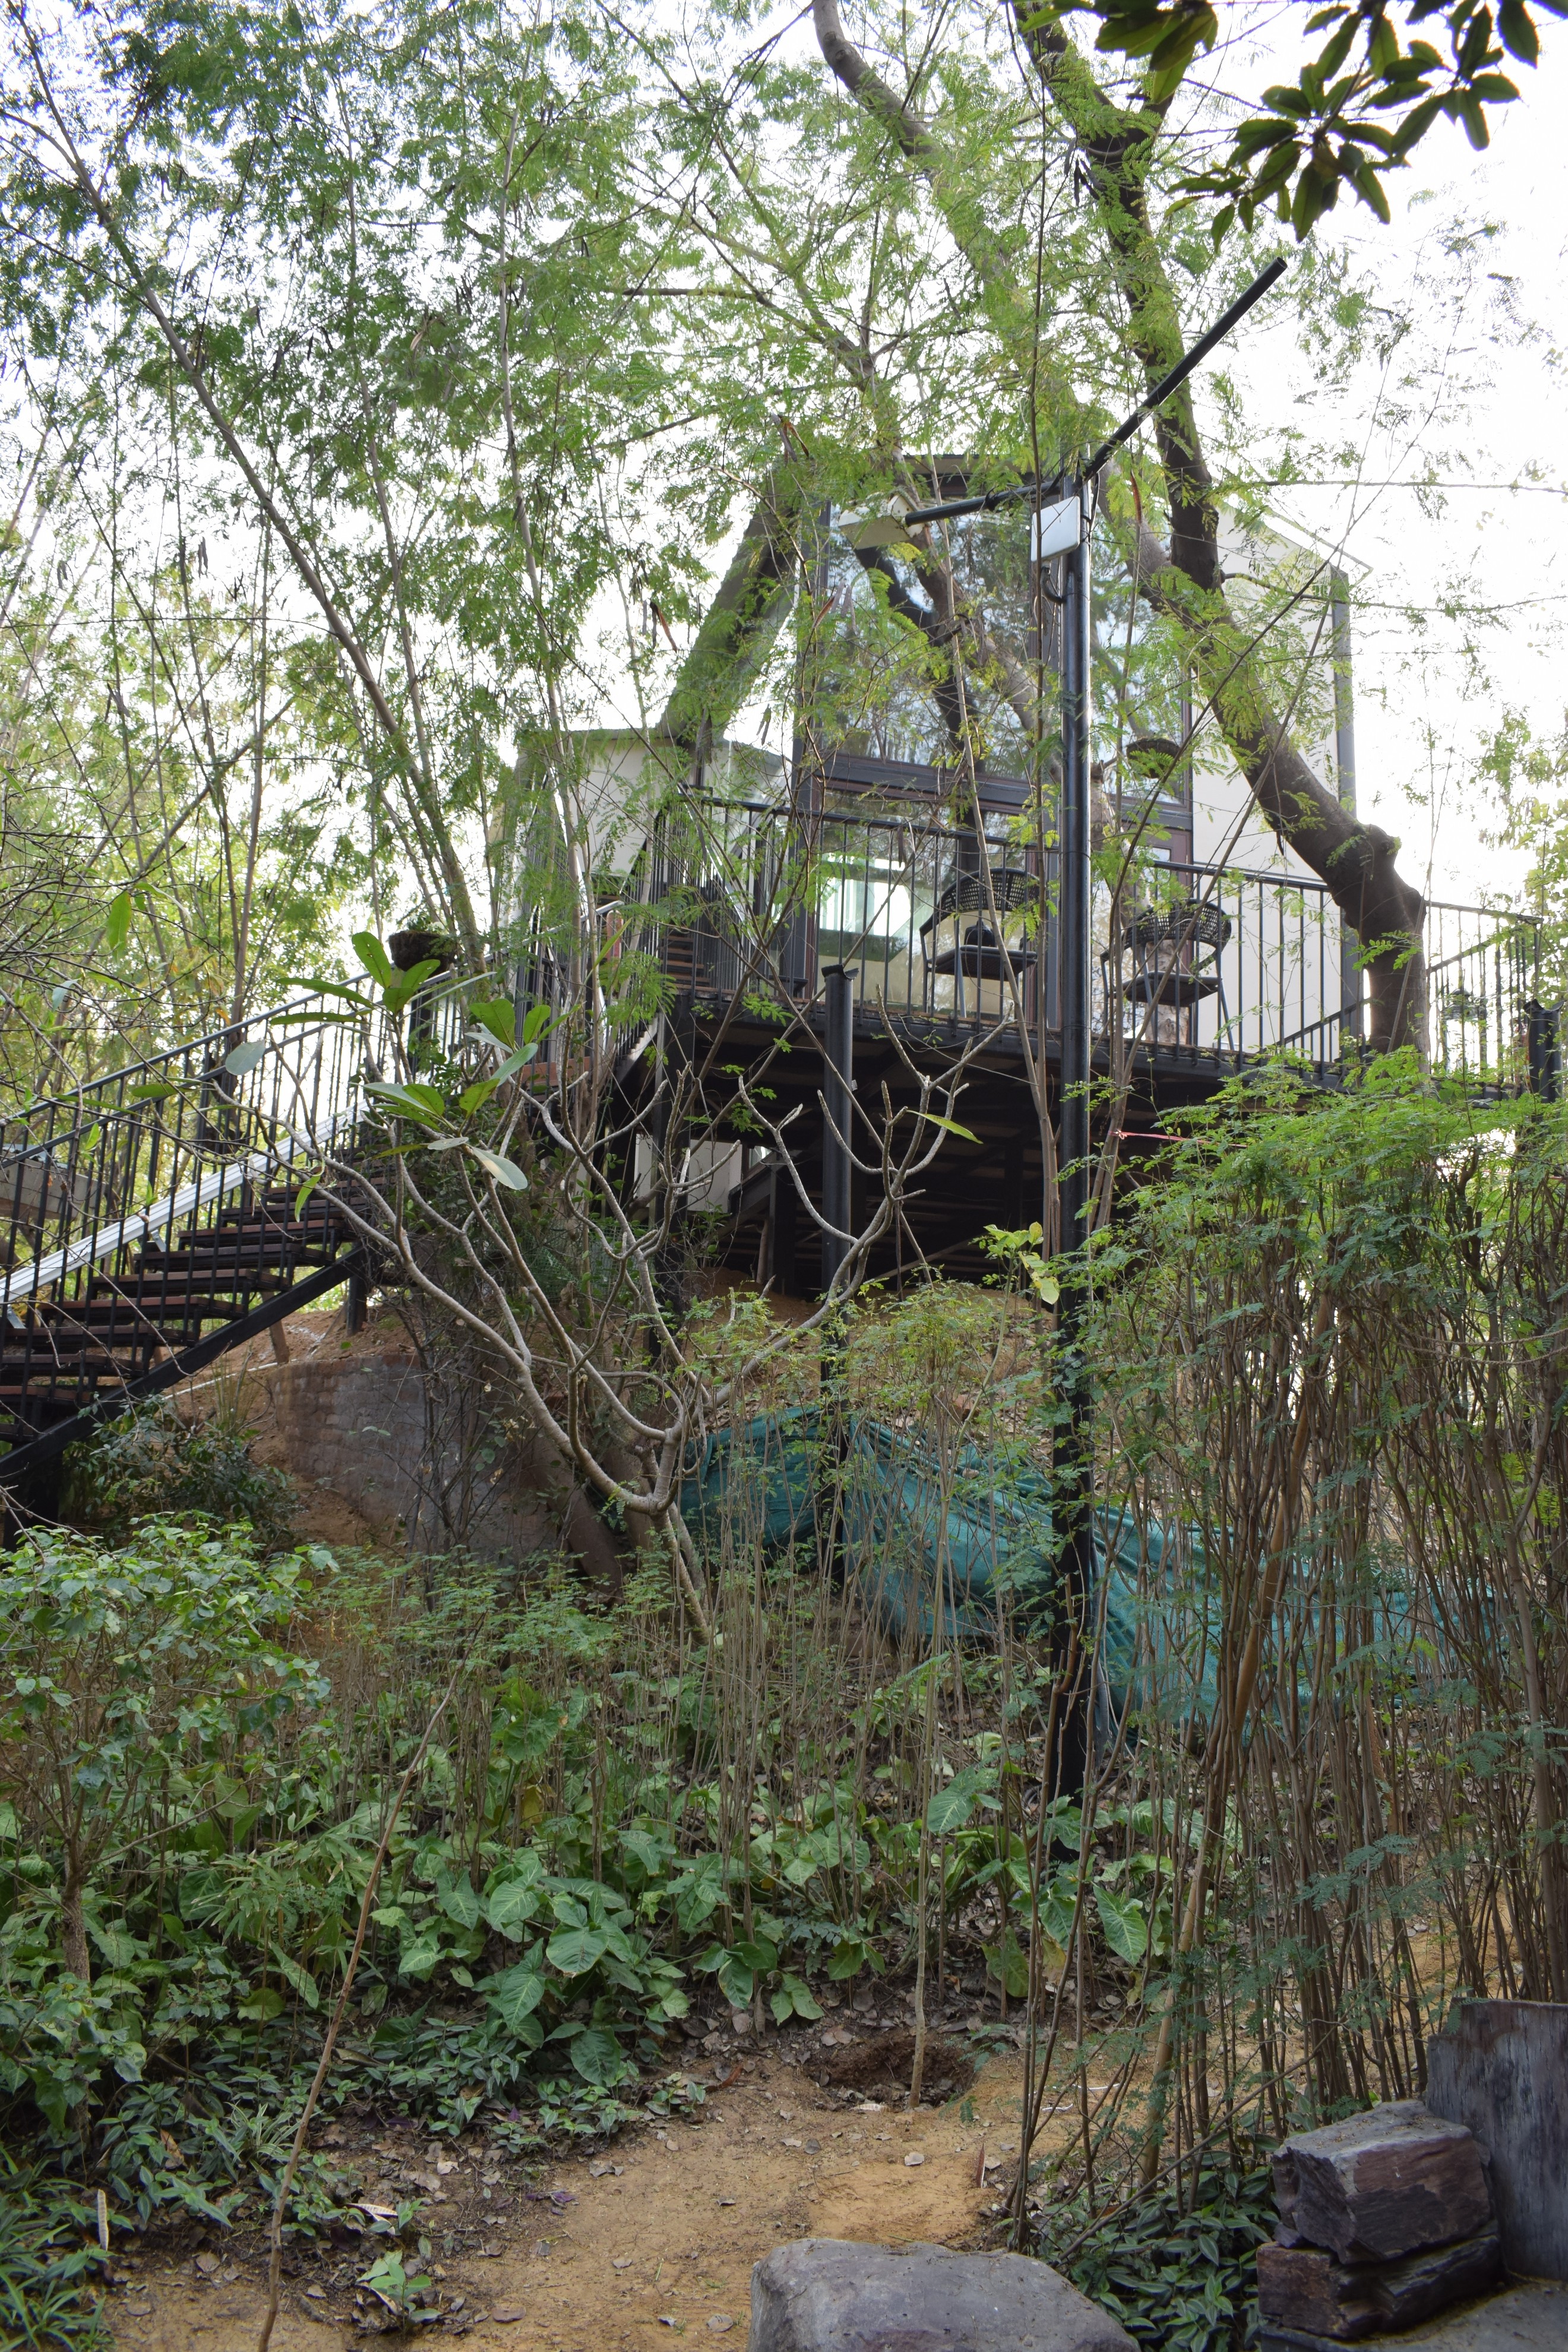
[1274,2098,1493,2263]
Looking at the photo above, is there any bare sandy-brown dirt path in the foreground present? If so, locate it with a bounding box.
[108,2056,1044,2352]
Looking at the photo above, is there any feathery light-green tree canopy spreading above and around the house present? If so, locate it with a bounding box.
[0,0,1540,1068]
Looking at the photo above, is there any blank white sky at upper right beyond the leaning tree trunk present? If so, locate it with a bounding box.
[1229,19,1568,901]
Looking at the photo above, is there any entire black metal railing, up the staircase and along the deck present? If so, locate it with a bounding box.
[0,846,1540,1420]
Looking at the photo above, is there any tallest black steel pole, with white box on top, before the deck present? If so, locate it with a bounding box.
[1051,485,1093,1790]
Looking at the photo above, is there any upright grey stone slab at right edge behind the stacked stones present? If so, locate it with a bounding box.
[1427,2002,1568,2277]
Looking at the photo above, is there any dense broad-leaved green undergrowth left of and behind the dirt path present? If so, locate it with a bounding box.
[0,1486,1071,2230]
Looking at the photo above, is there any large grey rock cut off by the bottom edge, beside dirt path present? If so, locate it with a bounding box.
[748,2237,1136,2352]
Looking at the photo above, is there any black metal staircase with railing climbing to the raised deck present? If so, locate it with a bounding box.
[0,995,374,1487]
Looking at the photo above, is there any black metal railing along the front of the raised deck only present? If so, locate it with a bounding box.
[628,797,1540,1089]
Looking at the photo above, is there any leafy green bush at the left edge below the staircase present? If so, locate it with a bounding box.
[0,1519,327,2098]
